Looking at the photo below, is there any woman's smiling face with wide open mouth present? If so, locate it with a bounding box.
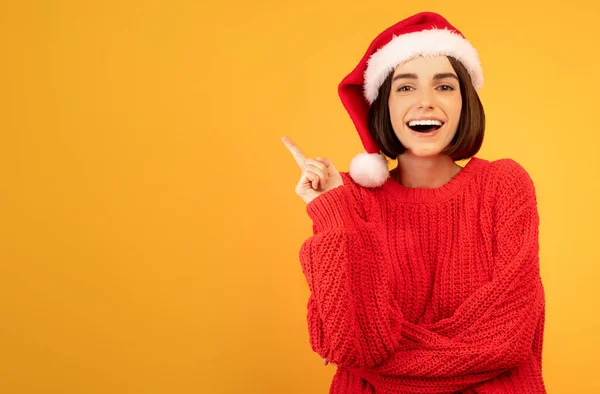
[388,56,462,157]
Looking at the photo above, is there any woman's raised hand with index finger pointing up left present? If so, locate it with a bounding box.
[281,137,344,204]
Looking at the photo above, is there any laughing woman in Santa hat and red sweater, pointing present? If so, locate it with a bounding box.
[283,13,545,393]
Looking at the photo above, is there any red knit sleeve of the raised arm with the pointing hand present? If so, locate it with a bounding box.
[300,175,402,367]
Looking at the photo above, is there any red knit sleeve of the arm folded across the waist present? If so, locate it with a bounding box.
[353,160,545,393]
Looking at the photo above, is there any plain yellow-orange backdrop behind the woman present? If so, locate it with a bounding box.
[0,0,600,394]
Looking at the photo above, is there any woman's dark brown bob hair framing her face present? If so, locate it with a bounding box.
[368,56,485,161]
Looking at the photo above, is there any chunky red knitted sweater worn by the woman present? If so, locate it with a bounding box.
[300,157,546,394]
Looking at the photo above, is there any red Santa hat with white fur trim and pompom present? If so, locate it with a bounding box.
[338,12,483,187]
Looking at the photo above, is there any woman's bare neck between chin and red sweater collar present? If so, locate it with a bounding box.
[390,151,462,188]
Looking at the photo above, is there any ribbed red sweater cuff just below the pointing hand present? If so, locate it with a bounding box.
[306,185,362,233]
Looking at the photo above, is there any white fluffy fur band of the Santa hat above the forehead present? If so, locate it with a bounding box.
[364,28,483,104]
